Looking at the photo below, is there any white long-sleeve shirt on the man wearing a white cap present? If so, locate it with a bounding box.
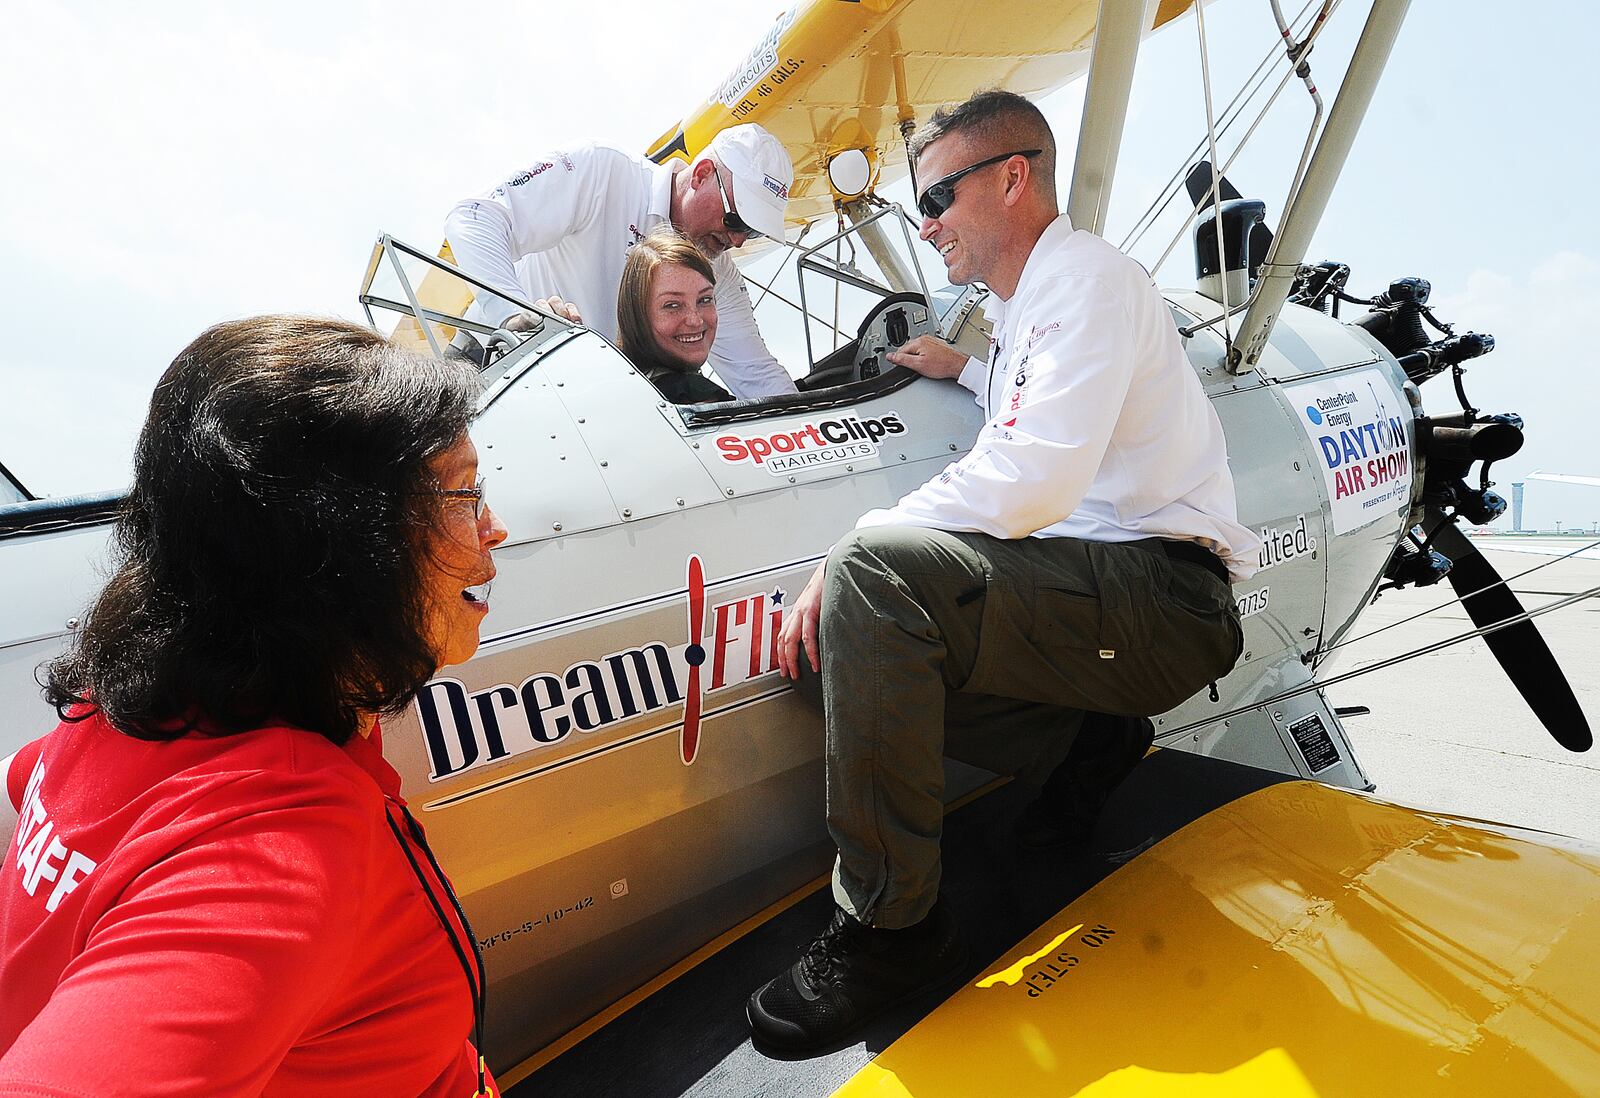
[445,144,795,397]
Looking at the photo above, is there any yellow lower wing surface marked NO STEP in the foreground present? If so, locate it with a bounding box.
[837,783,1600,1098]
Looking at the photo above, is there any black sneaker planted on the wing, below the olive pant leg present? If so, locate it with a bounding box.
[744,901,966,1052]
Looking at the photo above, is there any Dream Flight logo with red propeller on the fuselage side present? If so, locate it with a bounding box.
[416,557,784,781]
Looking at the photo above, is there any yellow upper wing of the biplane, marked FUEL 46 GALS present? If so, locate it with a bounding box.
[650,0,1192,224]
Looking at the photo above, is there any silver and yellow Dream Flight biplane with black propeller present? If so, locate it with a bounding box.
[0,0,1600,1096]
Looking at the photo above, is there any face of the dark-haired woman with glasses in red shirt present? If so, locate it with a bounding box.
[422,435,506,667]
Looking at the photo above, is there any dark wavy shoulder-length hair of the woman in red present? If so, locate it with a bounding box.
[45,317,478,744]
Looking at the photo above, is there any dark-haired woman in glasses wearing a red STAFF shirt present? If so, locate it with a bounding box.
[0,317,506,1098]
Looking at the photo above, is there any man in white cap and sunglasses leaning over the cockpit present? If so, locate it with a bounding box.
[445,125,795,399]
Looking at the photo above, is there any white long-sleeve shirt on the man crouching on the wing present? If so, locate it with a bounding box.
[856,214,1261,583]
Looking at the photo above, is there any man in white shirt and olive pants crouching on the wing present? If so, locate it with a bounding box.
[747,91,1259,1050]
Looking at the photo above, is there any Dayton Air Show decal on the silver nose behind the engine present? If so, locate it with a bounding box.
[1288,370,1411,535]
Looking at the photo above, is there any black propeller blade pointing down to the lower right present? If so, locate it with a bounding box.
[1429,521,1594,751]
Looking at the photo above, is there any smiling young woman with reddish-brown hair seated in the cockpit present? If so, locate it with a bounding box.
[616,227,733,403]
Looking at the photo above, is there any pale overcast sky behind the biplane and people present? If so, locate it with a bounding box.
[0,0,1600,527]
